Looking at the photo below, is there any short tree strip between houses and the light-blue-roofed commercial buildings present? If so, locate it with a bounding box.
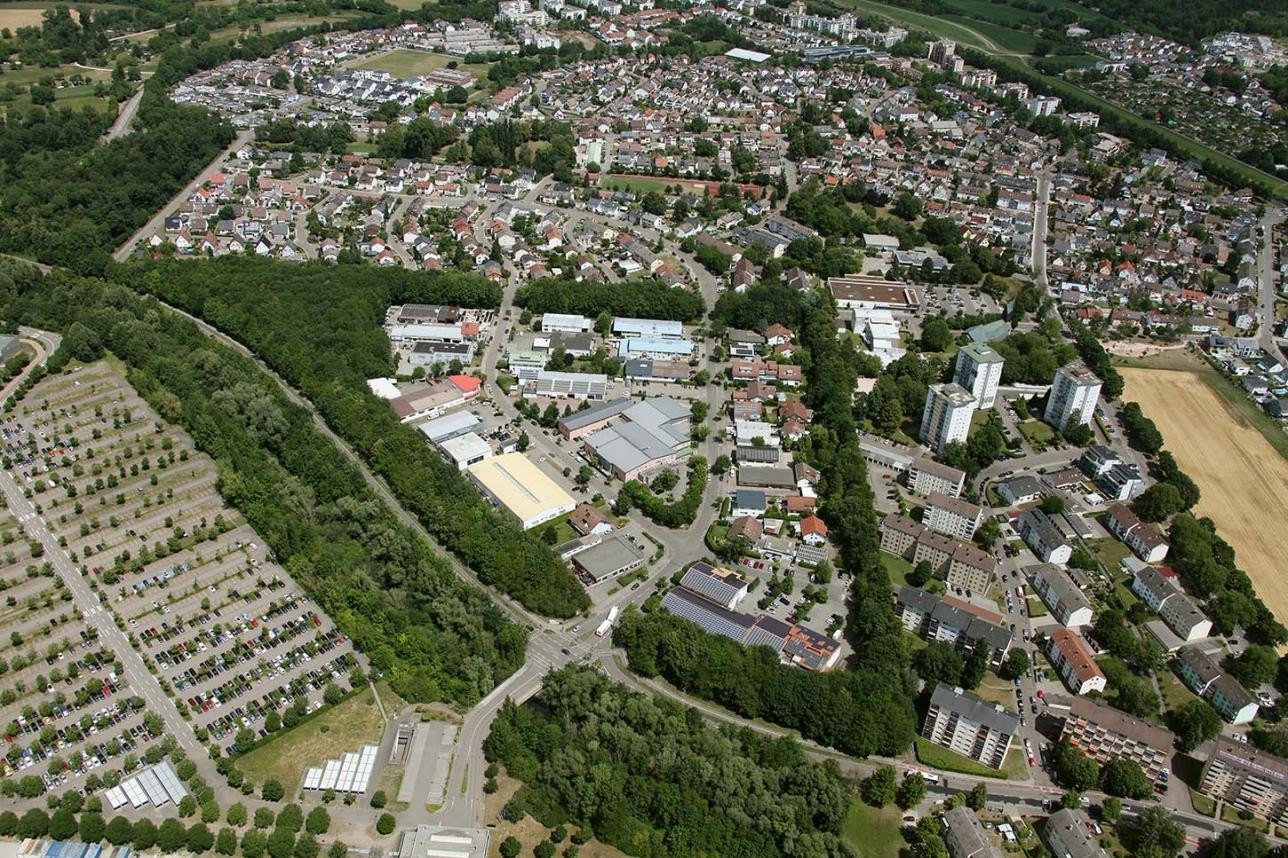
[514,277,706,322]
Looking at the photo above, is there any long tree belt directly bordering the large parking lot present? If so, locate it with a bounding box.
[0,257,526,706]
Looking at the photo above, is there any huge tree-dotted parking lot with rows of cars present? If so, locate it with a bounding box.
[0,363,354,788]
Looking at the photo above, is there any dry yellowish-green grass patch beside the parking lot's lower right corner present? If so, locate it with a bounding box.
[237,688,389,795]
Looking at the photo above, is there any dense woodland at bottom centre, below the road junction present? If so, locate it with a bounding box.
[483,667,854,858]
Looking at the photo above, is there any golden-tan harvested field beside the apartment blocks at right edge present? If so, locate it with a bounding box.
[1119,367,1288,624]
